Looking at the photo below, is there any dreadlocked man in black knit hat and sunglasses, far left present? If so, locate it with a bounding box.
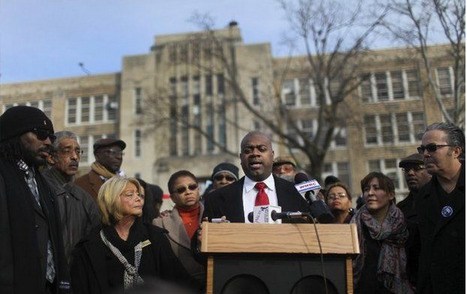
[0,106,70,294]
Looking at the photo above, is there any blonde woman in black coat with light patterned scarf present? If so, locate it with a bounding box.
[71,176,195,294]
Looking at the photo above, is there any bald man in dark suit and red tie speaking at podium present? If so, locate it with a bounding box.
[204,131,309,223]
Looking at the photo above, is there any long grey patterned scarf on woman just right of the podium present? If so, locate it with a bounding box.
[351,204,413,293]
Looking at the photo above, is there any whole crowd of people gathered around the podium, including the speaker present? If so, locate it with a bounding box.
[0,106,465,293]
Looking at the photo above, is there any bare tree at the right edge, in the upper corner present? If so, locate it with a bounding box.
[381,0,465,128]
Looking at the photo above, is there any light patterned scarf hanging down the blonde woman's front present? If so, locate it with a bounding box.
[100,230,144,290]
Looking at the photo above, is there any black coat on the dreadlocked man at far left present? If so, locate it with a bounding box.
[0,160,69,294]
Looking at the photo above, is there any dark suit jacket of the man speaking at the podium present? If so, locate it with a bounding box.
[204,177,309,223]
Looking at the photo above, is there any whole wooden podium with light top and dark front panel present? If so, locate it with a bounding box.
[201,222,360,294]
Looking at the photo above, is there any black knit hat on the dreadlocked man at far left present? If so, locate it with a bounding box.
[0,106,54,142]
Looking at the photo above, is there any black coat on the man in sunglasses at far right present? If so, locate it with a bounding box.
[416,166,465,294]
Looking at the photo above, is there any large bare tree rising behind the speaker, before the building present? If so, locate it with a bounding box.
[144,0,386,180]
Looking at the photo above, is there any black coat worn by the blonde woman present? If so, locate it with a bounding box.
[71,221,194,294]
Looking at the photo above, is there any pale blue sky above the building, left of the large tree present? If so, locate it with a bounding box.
[0,0,296,84]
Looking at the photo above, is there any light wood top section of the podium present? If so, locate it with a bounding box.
[201,222,360,254]
